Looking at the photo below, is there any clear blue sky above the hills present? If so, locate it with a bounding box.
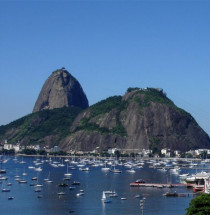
[0,0,210,134]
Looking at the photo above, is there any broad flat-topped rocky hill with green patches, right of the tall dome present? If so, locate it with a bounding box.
[61,88,210,151]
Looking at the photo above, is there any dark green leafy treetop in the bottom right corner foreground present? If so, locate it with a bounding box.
[186,194,210,215]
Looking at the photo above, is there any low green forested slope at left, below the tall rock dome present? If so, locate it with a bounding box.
[0,107,81,146]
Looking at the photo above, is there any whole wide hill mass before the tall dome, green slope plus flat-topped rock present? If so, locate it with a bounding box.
[0,88,210,151]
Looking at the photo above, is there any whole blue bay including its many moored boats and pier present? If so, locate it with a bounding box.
[0,156,209,215]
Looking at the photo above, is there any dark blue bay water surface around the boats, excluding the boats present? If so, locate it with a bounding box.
[0,157,199,215]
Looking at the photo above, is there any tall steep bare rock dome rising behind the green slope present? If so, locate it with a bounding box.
[33,68,89,112]
